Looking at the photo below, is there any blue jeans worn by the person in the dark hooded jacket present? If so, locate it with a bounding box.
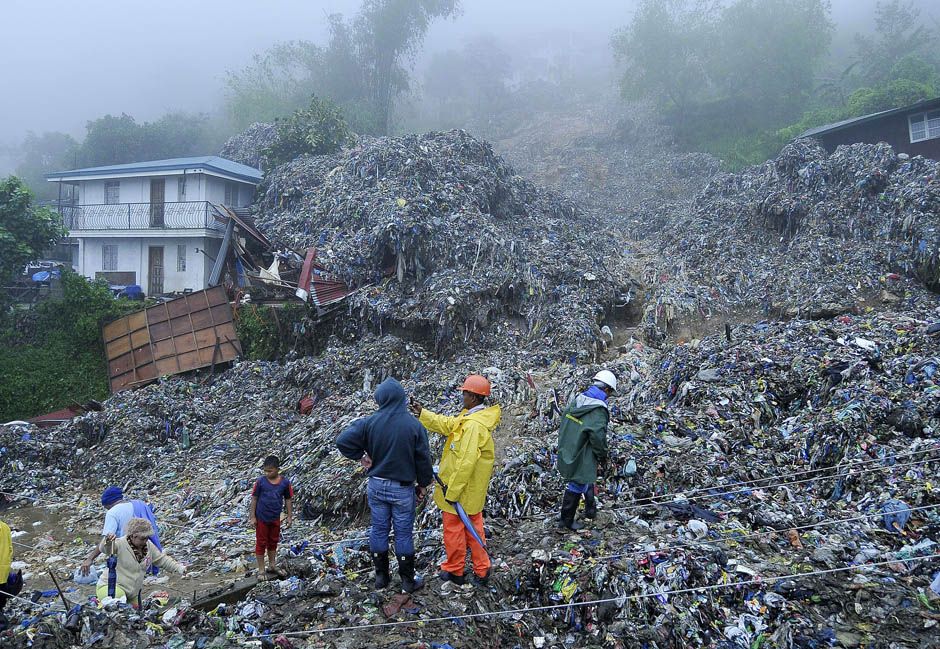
[366,478,415,556]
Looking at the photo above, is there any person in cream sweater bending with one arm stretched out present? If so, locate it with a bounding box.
[96,518,186,608]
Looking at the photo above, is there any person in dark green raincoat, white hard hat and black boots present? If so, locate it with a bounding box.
[557,370,617,530]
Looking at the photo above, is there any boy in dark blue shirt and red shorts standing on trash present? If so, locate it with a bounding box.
[248,455,294,579]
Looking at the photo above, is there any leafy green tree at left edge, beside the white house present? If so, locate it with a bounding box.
[0,176,64,295]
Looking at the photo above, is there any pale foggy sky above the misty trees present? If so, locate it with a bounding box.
[0,0,930,174]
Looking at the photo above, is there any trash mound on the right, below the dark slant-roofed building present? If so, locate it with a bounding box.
[643,140,940,327]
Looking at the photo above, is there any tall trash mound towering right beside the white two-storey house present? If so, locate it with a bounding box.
[256,126,636,362]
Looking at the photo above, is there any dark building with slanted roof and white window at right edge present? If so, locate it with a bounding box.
[800,97,940,160]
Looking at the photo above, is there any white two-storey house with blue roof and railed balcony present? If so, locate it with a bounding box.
[46,156,261,295]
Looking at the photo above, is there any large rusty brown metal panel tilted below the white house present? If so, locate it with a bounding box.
[103,286,242,392]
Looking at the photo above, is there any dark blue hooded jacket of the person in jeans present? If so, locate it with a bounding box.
[336,378,434,487]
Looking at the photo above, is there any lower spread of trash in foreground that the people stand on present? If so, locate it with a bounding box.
[2,306,940,648]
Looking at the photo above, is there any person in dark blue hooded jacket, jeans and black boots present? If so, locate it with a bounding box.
[336,378,434,593]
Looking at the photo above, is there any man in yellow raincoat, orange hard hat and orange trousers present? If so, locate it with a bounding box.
[410,374,502,585]
